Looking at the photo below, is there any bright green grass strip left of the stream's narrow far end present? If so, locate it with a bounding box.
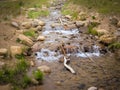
[28,10,49,19]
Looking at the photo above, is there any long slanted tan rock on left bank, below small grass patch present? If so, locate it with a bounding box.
[18,34,33,46]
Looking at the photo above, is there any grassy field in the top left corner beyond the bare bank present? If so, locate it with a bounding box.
[0,0,49,20]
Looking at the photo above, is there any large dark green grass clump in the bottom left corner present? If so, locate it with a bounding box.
[0,59,31,90]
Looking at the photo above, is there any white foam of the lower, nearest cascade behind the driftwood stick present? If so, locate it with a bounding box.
[36,45,100,62]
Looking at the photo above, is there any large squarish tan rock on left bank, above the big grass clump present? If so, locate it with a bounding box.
[10,46,23,57]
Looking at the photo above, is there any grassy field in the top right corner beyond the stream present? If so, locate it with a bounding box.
[69,0,120,14]
